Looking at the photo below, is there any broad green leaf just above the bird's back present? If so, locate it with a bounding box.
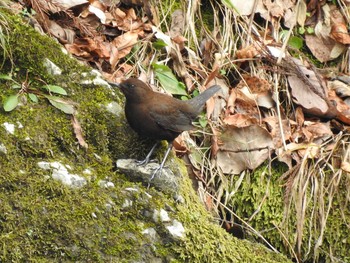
[152,63,187,95]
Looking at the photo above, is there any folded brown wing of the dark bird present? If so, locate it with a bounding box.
[150,108,193,133]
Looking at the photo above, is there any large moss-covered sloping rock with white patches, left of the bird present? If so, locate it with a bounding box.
[0,7,289,262]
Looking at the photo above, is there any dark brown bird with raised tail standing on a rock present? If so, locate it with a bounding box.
[109,78,220,180]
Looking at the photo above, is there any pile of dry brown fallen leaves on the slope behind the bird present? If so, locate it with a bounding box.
[17,0,350,179]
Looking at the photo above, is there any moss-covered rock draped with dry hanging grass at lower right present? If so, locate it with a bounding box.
[227,163,350,262]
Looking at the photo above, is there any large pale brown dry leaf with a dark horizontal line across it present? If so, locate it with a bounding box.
[217,125,274,174]
